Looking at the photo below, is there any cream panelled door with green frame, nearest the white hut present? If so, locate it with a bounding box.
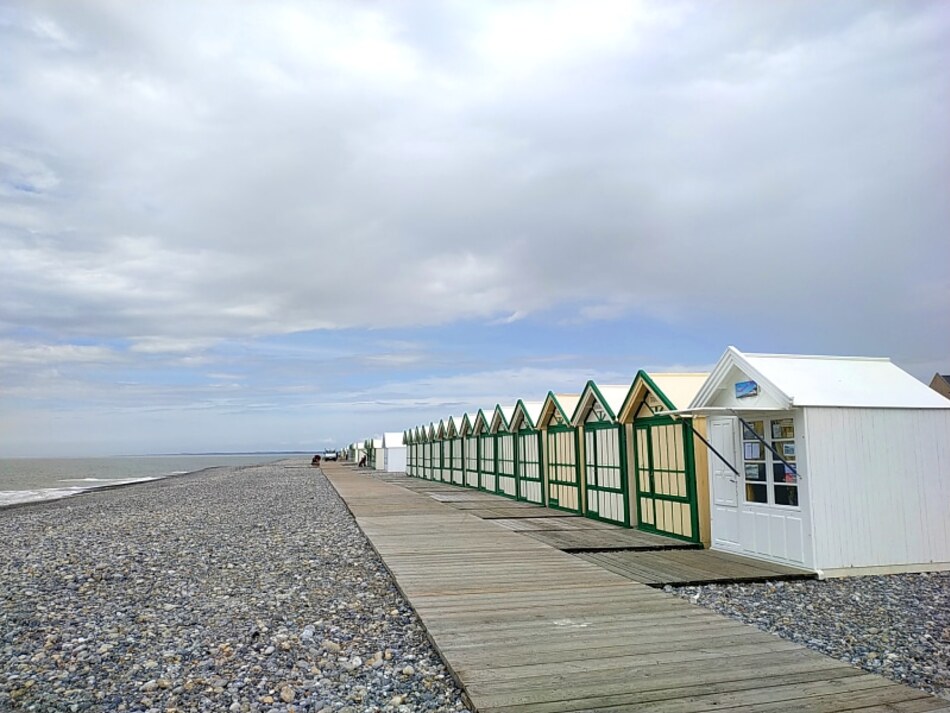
[634,418,699,542]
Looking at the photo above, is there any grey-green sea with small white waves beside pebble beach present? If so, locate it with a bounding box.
[0,453,305,507]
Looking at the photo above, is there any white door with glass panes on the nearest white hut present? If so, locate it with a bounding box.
[739,414,811,566]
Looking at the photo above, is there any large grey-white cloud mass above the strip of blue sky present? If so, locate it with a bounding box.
[0,2,950,354]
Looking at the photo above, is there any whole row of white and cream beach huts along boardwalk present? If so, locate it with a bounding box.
[348,347,950,576]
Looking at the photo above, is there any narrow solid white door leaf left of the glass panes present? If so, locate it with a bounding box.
[709,418,742,551]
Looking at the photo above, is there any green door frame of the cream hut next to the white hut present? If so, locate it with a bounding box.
[633,416,700,542]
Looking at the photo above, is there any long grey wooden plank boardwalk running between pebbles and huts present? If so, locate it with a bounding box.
[323,464,950,713]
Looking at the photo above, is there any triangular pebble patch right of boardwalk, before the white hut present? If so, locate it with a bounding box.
[665,572,950,699]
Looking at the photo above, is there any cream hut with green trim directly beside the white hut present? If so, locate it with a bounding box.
[618,370,710,545]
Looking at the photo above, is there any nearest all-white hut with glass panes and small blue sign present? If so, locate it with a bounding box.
[689,347,950,576]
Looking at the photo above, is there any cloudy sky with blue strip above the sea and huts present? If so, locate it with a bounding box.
[0,0,950,457]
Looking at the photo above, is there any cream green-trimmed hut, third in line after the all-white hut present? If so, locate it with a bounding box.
[538,391,584,513]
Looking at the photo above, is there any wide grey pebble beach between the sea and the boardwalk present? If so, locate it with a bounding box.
[0,464,466,713]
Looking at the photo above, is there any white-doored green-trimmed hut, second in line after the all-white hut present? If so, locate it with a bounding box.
[571,381,631,527]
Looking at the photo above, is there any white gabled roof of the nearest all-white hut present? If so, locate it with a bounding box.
[690,347,950,410]
